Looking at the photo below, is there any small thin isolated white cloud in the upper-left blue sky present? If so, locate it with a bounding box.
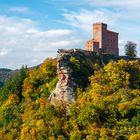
[9,7,30,13]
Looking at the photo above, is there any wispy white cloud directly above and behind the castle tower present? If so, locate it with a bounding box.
[63,9,120,31]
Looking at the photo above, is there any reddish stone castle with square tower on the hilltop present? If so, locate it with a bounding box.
[86,23,119,56]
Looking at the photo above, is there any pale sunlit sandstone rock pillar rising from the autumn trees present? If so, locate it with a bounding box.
[49,50,76,103]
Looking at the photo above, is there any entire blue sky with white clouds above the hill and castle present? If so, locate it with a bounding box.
[0,0,140,69]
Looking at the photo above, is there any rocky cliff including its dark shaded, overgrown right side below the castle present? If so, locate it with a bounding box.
[49,50,99,104]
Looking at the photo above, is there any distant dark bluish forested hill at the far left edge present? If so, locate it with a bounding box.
[0,68,12,88]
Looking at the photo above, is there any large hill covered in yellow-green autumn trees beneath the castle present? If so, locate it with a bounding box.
[0,50,140,140]
